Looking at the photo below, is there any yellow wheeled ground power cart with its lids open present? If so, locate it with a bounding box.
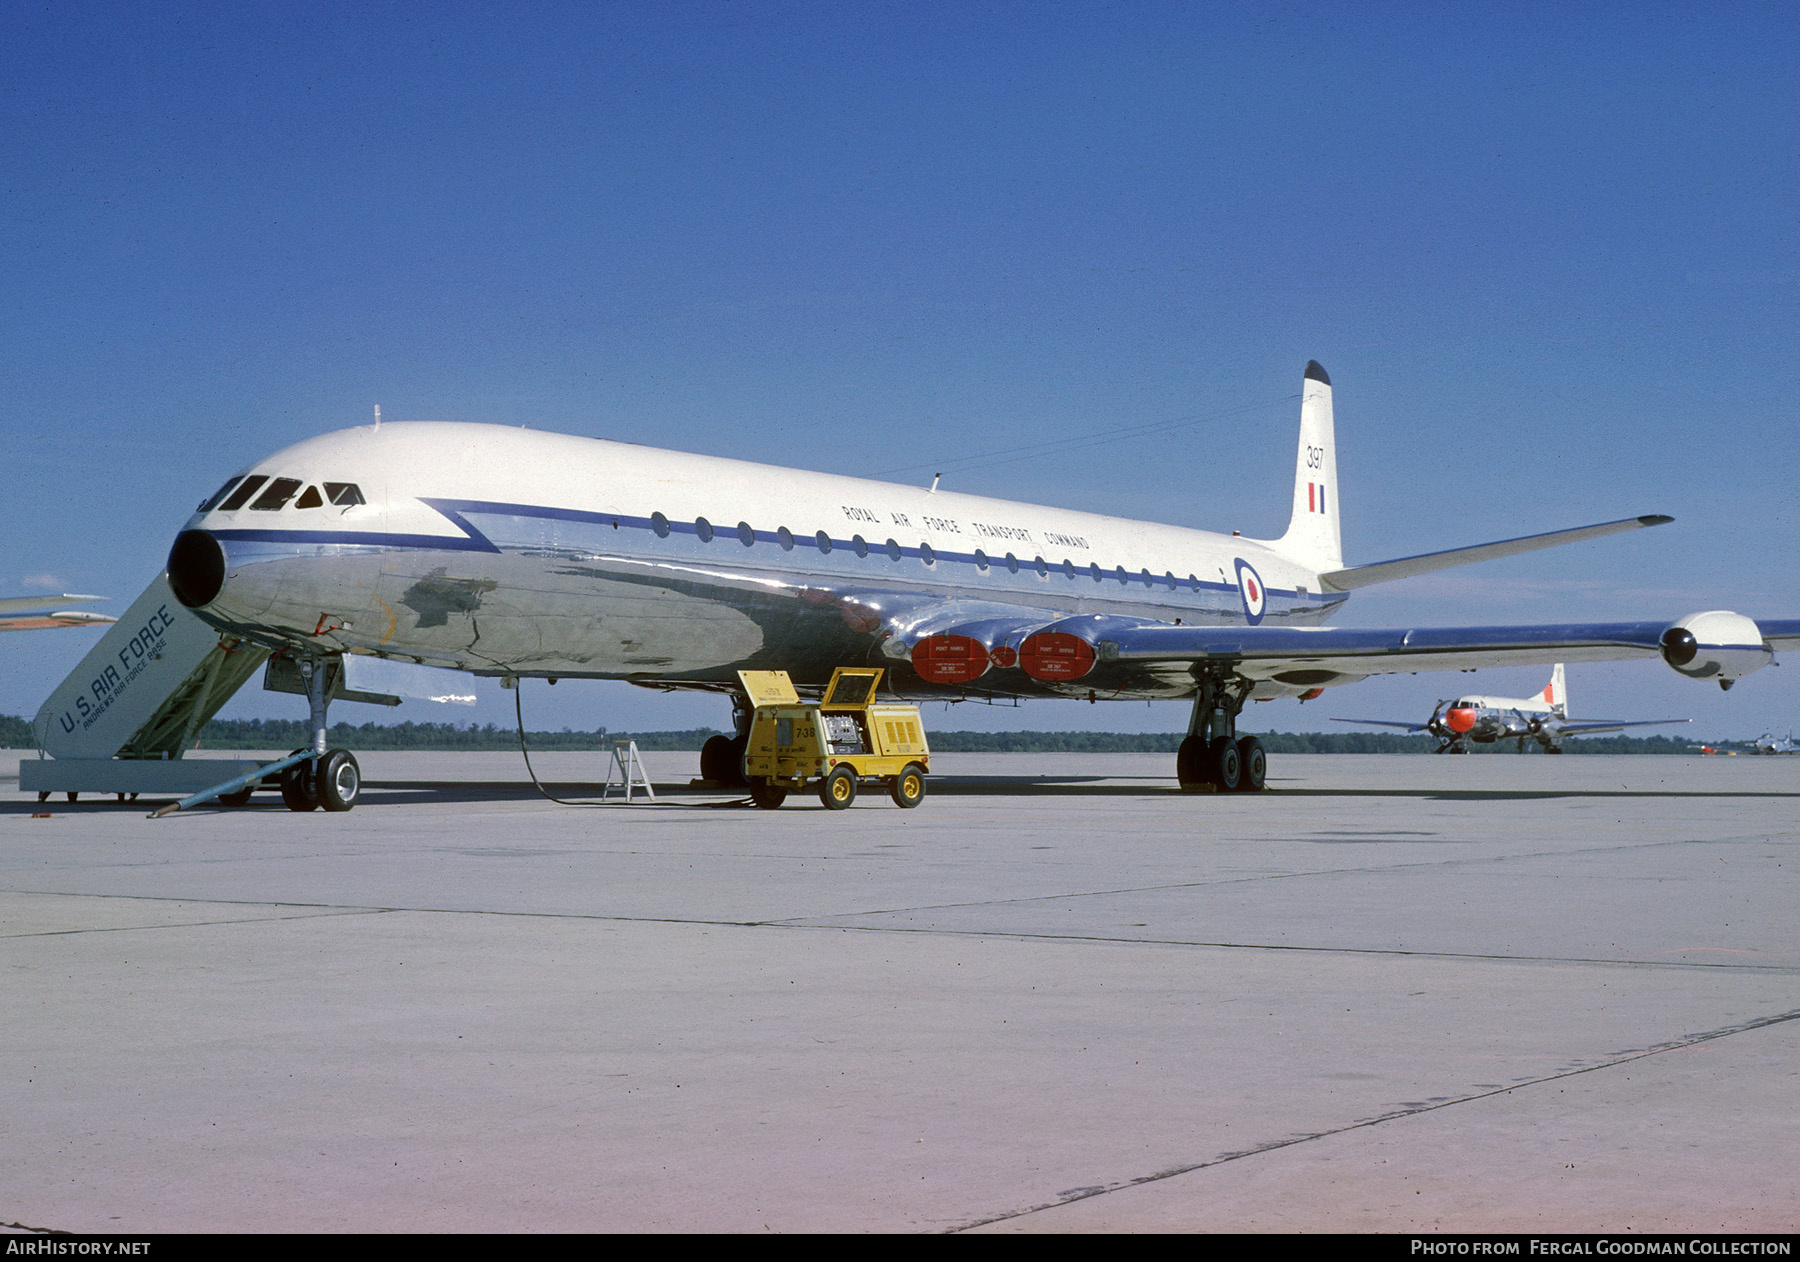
[738,666,931,810]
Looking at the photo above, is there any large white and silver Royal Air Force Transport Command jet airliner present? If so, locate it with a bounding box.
[151,364,1800,810]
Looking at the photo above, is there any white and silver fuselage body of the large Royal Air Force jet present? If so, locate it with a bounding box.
[187,423,1343,698]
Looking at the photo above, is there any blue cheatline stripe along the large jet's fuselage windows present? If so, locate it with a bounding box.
[211,488,1345,605]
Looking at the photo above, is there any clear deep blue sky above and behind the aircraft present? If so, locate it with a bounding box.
[0,2,1800,736]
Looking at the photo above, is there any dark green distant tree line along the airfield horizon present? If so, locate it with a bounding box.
[0,715,1713,754]
